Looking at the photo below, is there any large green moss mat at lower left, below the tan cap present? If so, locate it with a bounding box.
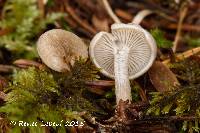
[0,59,101,133]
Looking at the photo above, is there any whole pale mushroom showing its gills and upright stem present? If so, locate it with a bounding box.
[89,23,157,103]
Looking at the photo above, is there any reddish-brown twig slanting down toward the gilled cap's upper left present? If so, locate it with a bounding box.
[65,4,97,34]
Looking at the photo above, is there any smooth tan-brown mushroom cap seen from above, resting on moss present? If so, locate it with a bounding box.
[37,29,88,72]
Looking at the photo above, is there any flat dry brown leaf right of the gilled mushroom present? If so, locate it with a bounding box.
[148,61,180,92]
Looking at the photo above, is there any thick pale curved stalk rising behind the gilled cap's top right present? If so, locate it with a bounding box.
[132,9,154,24]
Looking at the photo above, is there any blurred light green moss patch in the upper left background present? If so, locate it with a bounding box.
[0,0,63,58]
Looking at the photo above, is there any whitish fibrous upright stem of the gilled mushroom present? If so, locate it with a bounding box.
[114,45,132,104]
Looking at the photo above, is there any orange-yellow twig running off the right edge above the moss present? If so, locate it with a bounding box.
[162,47,200,65]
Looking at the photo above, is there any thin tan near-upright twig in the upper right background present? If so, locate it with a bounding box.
[172,5,188,53]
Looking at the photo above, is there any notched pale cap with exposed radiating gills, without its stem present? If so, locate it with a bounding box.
[89,23,157,79]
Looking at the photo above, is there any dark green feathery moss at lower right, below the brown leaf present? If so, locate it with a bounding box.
[147,59,200,131]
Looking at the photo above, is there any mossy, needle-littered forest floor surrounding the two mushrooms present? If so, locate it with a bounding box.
[0,0,200,133]
